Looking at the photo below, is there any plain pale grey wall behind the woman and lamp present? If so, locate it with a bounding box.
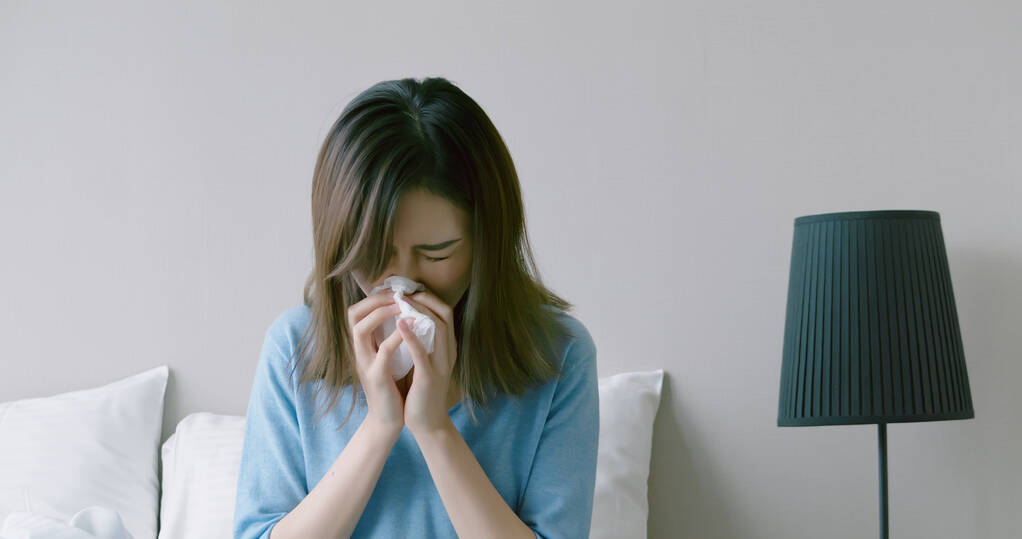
[0,0,1022,539]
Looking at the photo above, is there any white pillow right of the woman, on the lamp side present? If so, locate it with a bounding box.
[589,369,663,539]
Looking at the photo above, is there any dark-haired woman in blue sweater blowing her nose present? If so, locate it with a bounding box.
[234,78,599,539]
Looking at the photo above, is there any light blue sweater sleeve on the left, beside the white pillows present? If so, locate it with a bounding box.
[233,318,308,539]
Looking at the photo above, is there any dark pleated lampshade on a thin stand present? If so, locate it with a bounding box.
[777,210,974,426]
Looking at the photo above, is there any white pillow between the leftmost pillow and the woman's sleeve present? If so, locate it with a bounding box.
[159,412,245,539]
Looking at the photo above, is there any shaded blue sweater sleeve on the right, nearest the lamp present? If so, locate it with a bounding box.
[518,324,600,539]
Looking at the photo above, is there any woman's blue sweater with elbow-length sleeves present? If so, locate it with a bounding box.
[233,305,600,539]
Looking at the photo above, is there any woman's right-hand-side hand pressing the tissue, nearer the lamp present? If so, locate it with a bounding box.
[394,291,458,437]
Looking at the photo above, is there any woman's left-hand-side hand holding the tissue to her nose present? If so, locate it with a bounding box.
[347,291,405,436]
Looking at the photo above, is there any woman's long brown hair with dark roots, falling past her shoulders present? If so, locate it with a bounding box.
[292,77,573,429]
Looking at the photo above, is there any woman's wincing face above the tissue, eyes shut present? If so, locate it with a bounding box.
[354,189,472,308]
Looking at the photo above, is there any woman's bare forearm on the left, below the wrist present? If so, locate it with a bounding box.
[270,418,401,539]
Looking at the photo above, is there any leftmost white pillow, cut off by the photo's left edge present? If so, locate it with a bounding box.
[0,365,169,539]
